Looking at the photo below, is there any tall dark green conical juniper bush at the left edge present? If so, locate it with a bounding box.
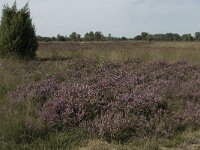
[0,2,38,59]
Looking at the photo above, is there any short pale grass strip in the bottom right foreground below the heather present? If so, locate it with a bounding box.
[77,130,200,150]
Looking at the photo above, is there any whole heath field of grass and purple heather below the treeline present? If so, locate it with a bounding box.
[0,41,200,150]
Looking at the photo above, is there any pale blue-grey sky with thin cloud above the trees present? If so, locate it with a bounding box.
[0,0,200,37]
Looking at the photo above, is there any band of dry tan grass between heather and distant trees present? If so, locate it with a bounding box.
[38,41,200,64]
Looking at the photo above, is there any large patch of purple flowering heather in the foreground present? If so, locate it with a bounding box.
[12,60,200,141]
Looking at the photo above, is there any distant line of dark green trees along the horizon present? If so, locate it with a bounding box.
[37,31,200,42]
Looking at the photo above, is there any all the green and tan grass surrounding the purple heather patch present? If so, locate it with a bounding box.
[0,41,200,150]
